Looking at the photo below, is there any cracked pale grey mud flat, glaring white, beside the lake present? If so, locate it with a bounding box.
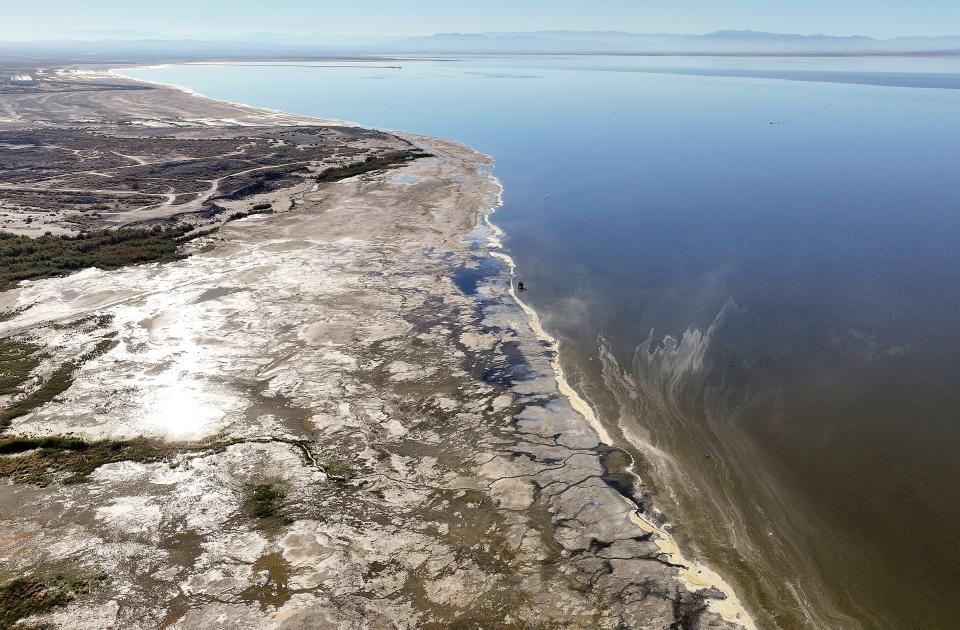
[0,70,750,629]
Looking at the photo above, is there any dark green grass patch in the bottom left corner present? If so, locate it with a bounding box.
[0,575,106,630]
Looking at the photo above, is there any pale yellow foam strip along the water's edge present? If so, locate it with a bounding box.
[483,188,757,630]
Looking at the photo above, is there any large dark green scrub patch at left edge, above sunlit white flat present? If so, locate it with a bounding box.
[0,226,192,291]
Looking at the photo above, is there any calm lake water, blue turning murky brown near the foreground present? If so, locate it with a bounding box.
[129,57,960,628]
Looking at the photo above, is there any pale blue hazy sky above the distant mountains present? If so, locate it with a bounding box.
[0,0,960,37]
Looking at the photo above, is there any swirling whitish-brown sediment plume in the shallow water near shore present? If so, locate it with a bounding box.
[598,300,861,628]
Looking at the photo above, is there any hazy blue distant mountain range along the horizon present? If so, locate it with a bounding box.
[0,30,960,57]
